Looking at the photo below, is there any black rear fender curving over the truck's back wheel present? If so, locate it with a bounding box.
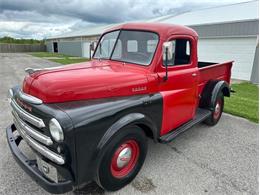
[200,80,230,110]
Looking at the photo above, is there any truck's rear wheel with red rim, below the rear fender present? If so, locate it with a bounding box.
[204,92,224,126]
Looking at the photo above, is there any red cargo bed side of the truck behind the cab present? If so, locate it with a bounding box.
[198,61,233,93]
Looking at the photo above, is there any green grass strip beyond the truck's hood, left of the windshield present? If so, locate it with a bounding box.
[29,52,88,64]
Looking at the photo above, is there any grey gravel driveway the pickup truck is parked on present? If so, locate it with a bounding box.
[0,53,258,195]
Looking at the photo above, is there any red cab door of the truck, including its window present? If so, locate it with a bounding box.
[160,38,198,135]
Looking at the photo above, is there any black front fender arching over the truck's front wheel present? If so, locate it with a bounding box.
[58,93,163,185]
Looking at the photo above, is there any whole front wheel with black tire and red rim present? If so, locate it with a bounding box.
[97,126,147,191]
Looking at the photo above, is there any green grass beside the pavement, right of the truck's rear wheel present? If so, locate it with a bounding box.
[224,82,259,123]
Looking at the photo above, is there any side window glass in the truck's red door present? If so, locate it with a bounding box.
[163,39,191,66]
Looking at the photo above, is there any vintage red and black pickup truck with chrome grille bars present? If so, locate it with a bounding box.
[6,23,233,193]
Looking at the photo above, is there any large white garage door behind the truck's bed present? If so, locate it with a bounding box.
[198,37,257,80]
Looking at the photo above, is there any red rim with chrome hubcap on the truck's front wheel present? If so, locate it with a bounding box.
[110,140,140,178]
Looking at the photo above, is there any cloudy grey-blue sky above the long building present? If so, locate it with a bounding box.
[0,0,254,39]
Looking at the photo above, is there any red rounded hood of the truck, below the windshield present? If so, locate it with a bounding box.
[23,60,152,103]
